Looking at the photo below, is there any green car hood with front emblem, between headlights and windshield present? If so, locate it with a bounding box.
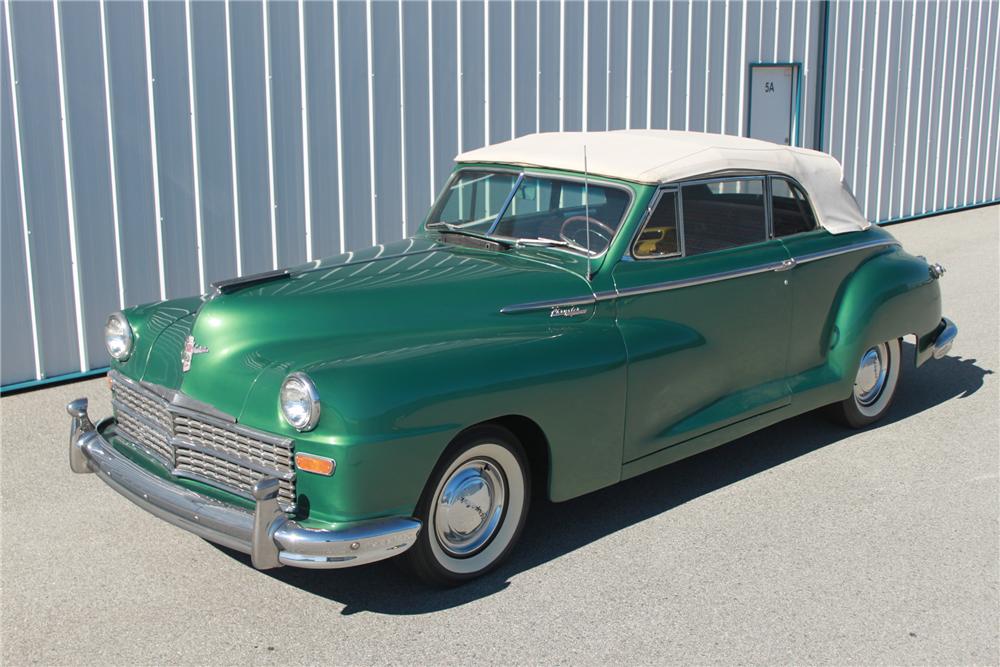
[122,237,590,416]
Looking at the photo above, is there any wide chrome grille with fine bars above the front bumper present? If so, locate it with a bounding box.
[111,373,295,510]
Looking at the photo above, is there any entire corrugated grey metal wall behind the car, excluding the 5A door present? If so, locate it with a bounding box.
[0,0,1000,387]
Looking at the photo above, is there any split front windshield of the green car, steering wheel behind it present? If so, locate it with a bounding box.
[426,169,629,255]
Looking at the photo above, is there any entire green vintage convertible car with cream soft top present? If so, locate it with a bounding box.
[68,131,957,585]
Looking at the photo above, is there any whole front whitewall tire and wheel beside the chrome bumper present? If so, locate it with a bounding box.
[406,426,531,586]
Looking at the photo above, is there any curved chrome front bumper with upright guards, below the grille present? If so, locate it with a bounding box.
[66,398,421,570]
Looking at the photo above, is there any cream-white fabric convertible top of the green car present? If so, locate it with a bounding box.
[455,130,871,234]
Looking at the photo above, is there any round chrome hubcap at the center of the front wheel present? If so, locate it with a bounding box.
[434,459,507,557]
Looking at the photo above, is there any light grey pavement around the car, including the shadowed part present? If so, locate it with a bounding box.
[0,206,1000,665]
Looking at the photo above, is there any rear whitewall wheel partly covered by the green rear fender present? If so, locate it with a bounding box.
[831,338,900,428]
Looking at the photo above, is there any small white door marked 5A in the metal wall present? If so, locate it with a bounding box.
[749,65,798,145]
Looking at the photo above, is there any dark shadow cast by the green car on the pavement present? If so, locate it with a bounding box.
[211,343,993,615]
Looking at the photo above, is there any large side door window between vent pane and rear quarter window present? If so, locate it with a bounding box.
[681,178,767,257]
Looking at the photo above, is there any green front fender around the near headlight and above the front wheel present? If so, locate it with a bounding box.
[240,306,625,522]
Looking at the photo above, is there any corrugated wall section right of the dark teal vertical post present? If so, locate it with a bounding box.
[820,2,998,221]
